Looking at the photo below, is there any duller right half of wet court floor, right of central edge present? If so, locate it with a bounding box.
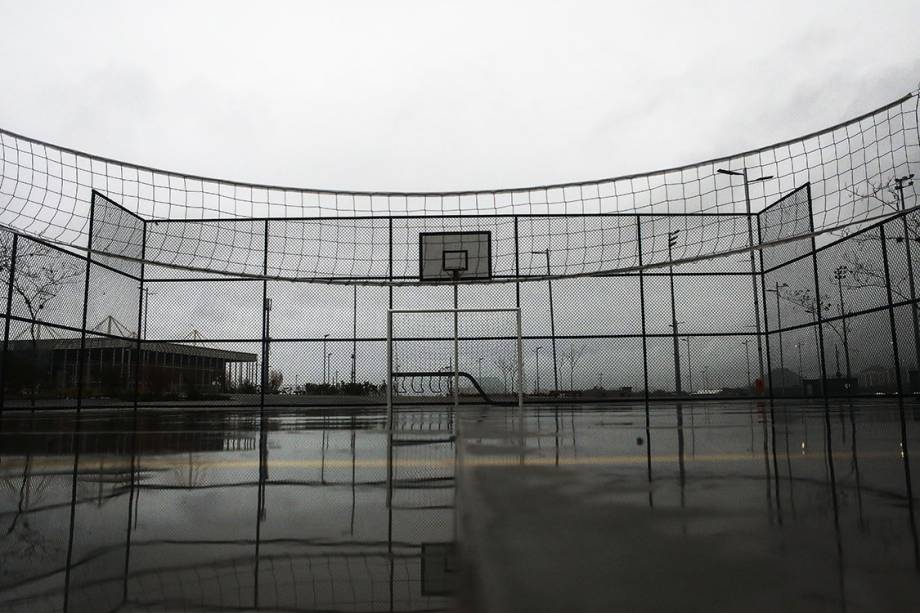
[459,402,920,612]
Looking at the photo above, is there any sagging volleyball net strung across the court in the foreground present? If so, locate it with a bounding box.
[0,88,920,282]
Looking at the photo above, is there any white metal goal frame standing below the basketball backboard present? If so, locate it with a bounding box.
[386,308,525,429]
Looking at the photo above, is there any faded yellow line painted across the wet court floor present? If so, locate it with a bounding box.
[0,452,901,478]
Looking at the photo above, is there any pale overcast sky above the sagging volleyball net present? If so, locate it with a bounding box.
[0,0,920,190]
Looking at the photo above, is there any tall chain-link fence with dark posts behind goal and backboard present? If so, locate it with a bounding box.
[0,183,920,408]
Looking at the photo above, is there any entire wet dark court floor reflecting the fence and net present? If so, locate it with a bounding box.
[0,401,920,611]
